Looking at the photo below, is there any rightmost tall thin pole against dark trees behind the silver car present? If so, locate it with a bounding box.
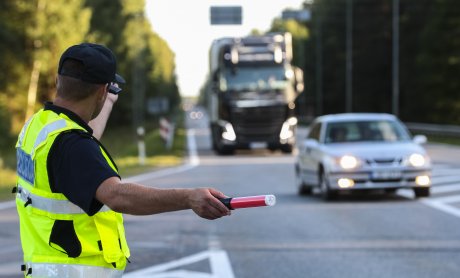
[392,0,399,116]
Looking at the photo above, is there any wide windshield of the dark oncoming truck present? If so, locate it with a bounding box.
[221,66,288,91]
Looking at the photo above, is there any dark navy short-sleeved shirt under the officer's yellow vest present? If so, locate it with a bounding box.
[45,102,119,216]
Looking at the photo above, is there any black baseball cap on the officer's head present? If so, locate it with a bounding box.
[58,43,125,85]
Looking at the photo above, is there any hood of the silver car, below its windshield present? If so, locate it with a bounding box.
[325,142,426,158]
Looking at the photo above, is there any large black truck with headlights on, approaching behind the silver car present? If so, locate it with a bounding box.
[206,33,304,155]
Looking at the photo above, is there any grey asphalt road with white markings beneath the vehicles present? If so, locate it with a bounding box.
[0,109,460,278]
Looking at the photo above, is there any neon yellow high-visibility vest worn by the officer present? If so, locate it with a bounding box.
[16,109,130,278]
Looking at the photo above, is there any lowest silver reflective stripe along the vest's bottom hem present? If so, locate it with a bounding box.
[25,262,123,278]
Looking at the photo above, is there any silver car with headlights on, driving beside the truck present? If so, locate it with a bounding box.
[295,113,431,200]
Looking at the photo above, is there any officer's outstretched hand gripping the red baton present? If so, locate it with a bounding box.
[189,188,231,220]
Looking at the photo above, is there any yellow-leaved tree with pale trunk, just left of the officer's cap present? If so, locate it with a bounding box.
[26,0,91,119]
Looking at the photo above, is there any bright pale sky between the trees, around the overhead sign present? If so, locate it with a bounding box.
[146,0,304,97]
